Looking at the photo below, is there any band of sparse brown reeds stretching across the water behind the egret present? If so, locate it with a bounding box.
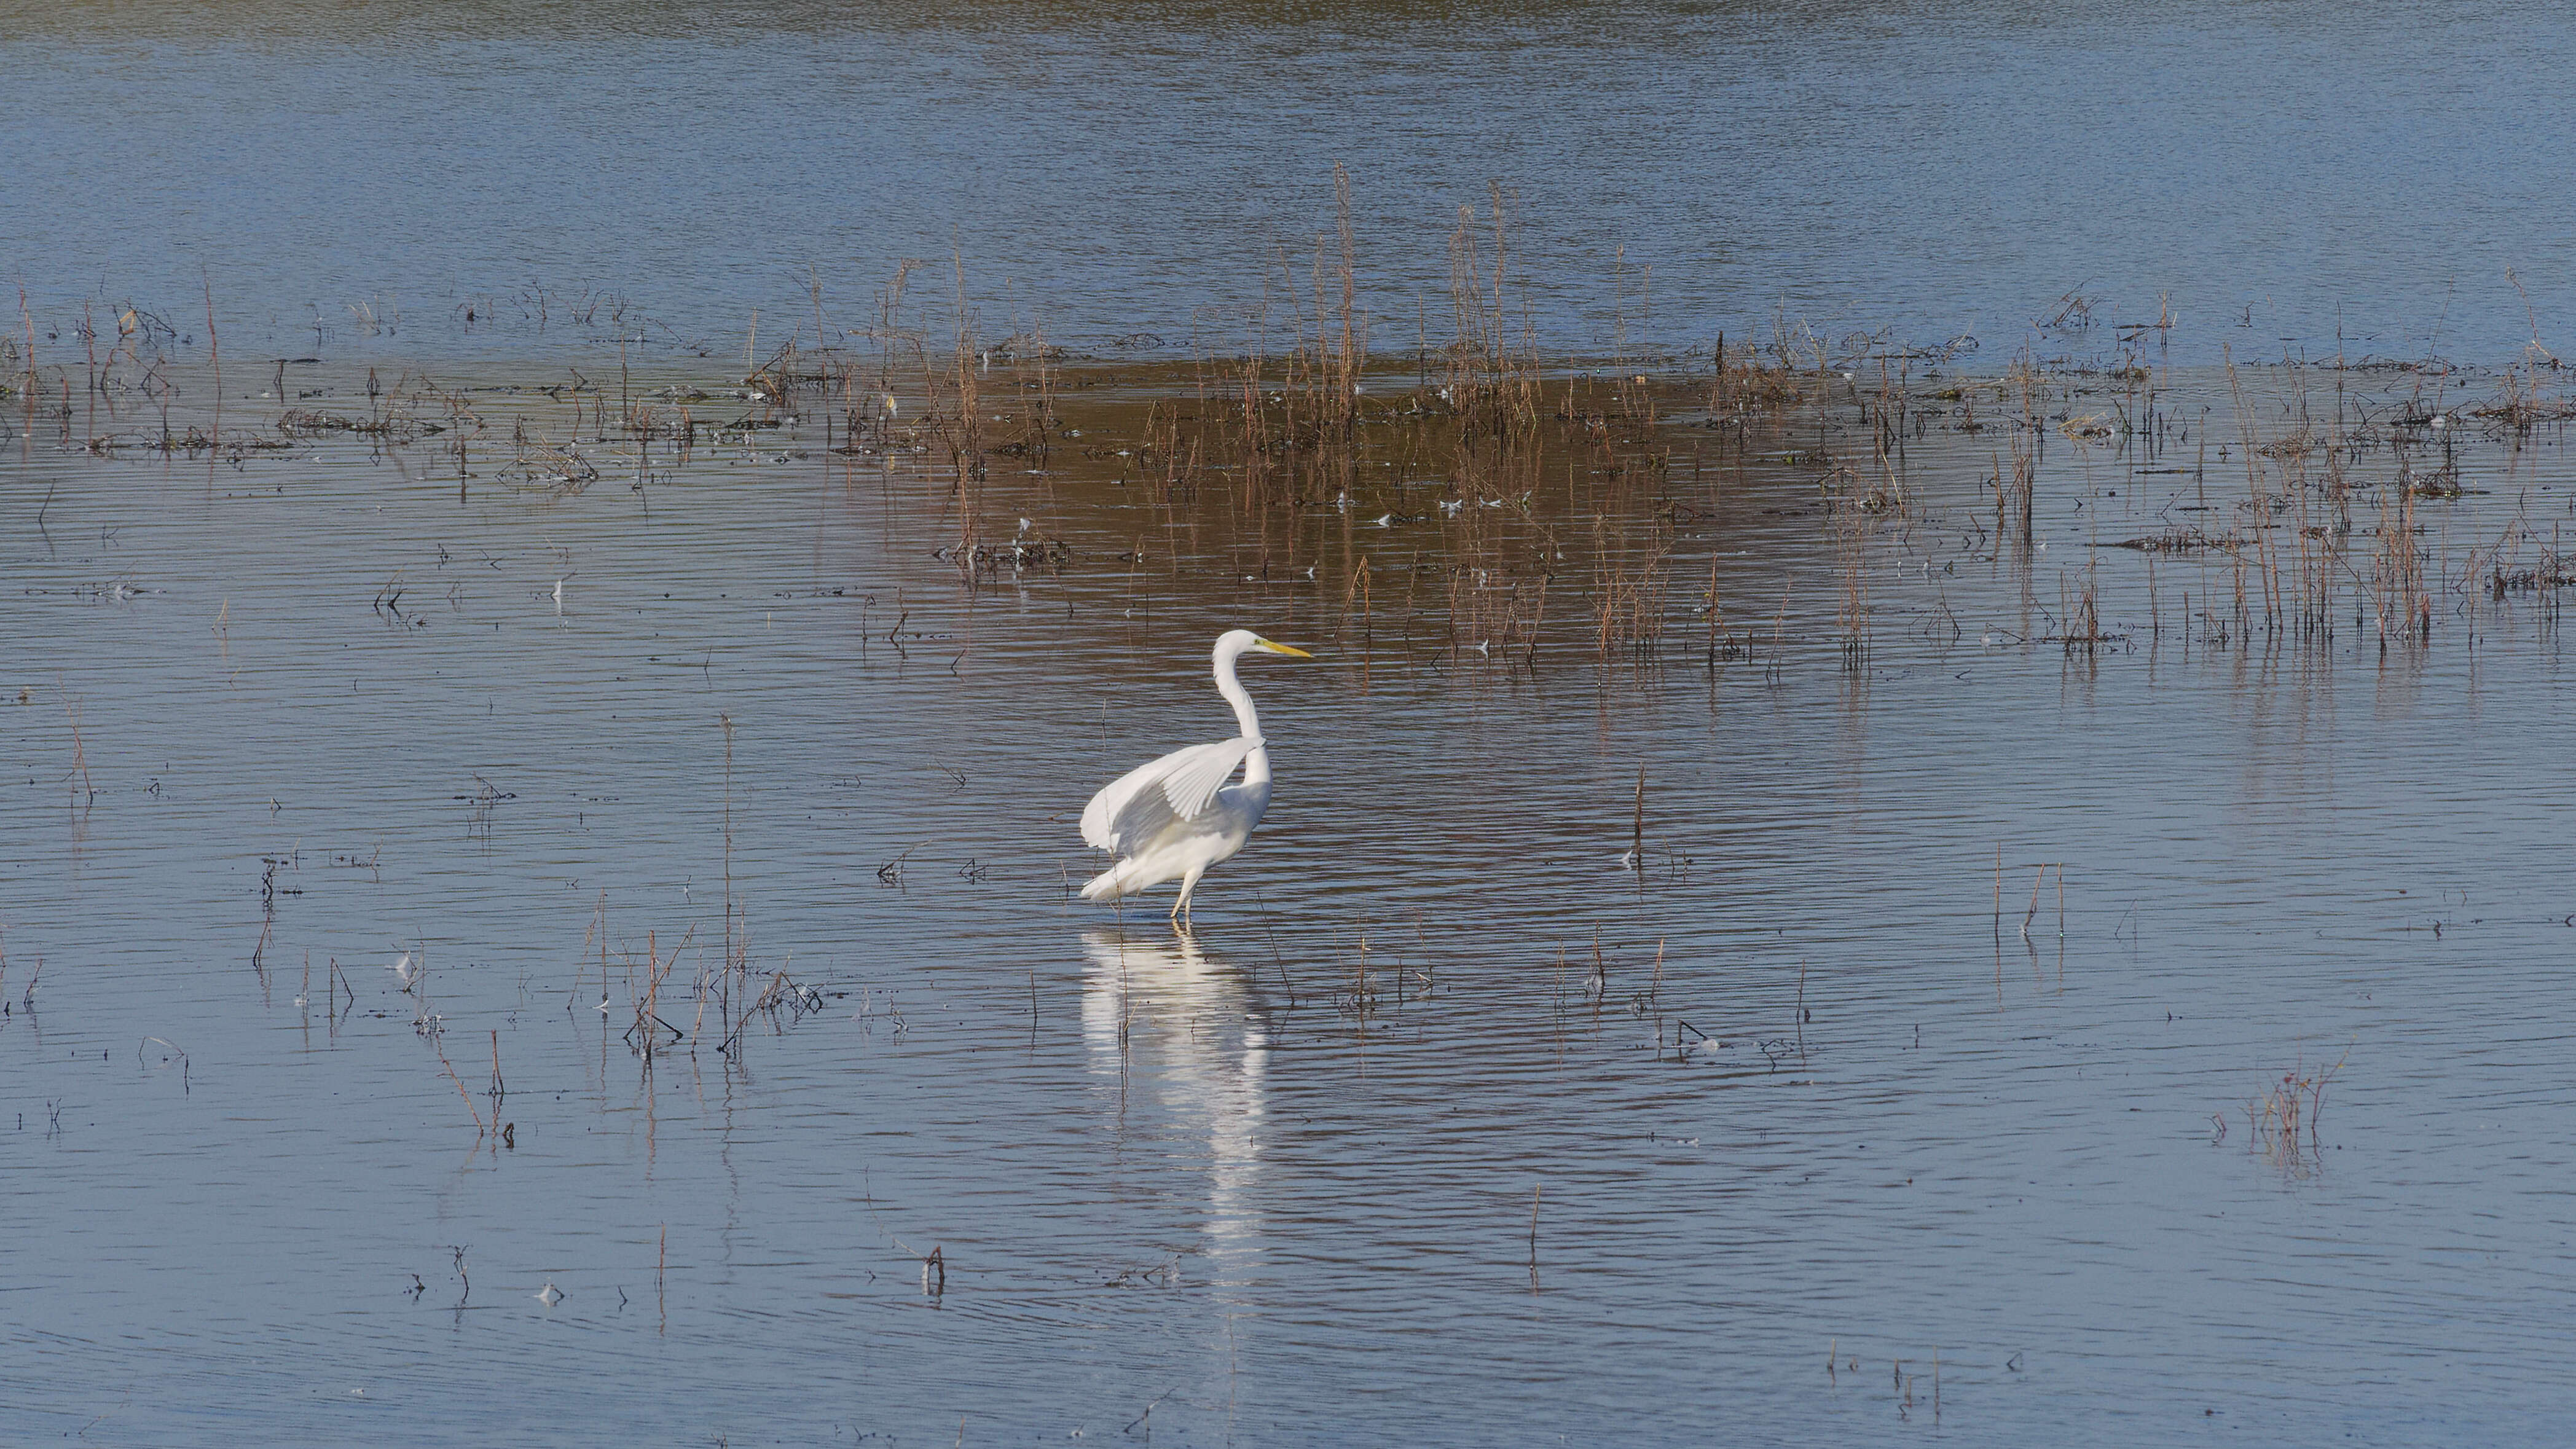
[20,178,2576,696]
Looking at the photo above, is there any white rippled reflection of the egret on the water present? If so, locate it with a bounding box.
[1082,931,1270,1281]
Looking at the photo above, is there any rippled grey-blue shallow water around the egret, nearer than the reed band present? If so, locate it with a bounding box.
[15,348,2576,1444]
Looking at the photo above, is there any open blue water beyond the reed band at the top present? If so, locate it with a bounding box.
[0,2,2576,361]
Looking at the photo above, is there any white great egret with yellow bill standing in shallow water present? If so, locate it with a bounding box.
[1082,629,1314,931]
